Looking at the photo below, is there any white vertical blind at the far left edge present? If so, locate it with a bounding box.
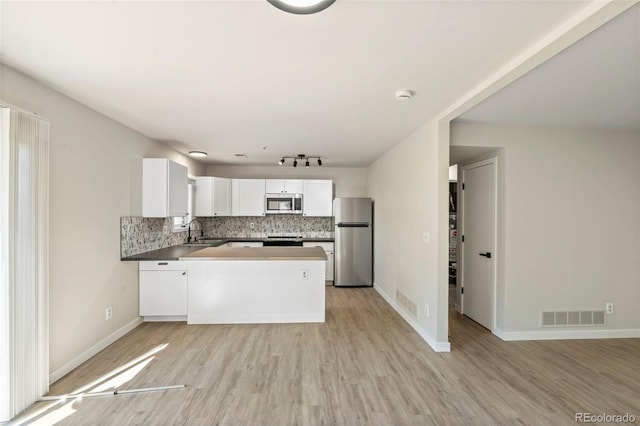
[0,108,49,421]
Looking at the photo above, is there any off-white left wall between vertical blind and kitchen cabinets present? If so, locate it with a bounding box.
[0,66,204,378]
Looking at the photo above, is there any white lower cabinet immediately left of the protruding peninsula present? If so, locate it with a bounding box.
[138,261,188,321]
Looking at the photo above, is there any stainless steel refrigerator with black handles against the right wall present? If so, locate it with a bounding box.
[333,198,373,287]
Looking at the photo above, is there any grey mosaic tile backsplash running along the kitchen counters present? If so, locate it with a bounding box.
[120,215,334,257]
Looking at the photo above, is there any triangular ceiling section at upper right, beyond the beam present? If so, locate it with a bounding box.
[457,5,640,129]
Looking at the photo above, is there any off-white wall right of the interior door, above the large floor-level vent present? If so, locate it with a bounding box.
[451,123,640,338]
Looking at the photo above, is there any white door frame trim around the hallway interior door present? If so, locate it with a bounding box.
[456,156,499,334]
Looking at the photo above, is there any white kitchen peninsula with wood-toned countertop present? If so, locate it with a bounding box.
[180,247,327,324]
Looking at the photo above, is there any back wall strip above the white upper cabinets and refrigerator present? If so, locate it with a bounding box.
[207,165,367,197]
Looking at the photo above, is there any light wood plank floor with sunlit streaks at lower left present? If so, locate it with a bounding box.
[12,287,640,426]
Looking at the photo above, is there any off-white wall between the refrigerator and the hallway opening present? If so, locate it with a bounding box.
[368,122,449,350]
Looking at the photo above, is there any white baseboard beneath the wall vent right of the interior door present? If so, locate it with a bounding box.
[493,328,640,342]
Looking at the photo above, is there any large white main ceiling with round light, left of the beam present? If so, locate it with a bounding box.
[0,0,615,166]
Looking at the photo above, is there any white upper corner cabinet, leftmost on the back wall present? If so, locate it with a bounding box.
[195,176,231,217]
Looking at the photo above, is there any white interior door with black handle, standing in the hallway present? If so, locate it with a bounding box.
[462,158,496,330]
